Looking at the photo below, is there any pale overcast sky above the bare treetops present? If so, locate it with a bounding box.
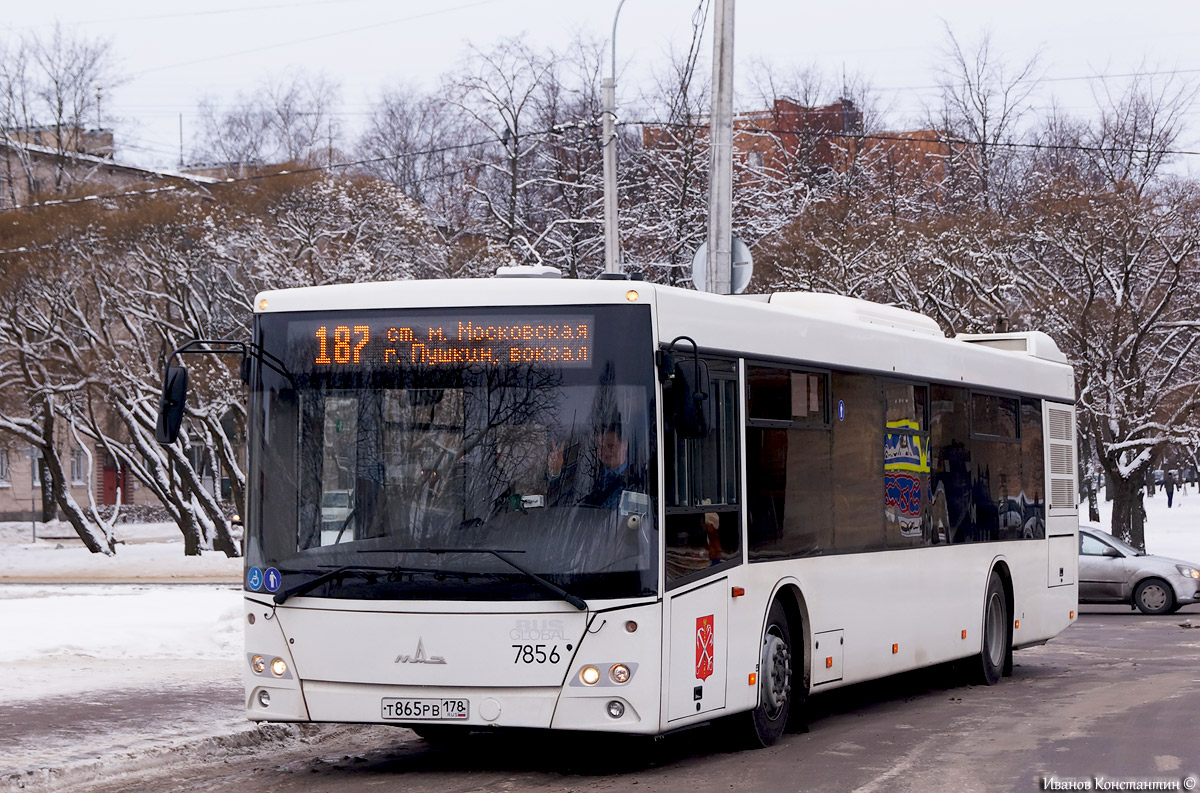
[0,0,1200,173]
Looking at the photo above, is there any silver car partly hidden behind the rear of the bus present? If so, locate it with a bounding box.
[1079,525,1200,614]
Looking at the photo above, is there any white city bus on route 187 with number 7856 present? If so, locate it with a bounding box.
[194,271,1078,745]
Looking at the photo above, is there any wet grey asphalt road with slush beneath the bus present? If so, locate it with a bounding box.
[0,606,1200,793]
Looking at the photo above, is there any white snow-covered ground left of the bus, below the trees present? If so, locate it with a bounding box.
[0,523,242,704]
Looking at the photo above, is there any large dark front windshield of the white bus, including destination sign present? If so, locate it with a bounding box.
[246,306,658,600]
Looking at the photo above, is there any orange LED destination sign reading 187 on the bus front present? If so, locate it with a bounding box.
[290,311,595,371]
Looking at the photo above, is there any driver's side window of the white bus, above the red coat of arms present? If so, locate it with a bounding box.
[665,359,742,585]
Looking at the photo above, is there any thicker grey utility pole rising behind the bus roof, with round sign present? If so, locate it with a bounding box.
[704,0,733,295]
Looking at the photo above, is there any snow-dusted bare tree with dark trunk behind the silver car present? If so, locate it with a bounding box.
[1022,166,1200,547]
